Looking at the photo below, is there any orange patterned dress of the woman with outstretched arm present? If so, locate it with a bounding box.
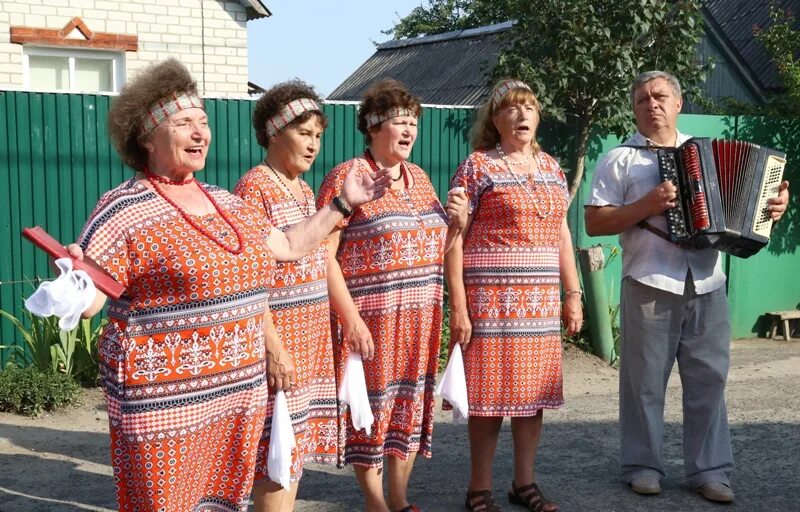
[78,179,274,512]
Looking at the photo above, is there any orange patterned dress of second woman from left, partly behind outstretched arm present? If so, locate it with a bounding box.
[234,167,339,483]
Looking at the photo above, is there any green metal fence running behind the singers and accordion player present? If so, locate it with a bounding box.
[0,91,800,367]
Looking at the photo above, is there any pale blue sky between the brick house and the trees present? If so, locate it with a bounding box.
[247,0,428,96]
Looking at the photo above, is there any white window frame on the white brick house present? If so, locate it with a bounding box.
[22,44,125,94]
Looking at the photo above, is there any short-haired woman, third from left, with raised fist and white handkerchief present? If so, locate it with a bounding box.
[317,80,466,512]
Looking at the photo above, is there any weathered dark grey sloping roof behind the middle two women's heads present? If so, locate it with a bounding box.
[327,22,511,105]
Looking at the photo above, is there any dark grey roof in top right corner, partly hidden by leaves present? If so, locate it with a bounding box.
[703,0,800,90]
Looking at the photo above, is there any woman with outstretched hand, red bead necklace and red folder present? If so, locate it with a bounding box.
[68,59,388,512]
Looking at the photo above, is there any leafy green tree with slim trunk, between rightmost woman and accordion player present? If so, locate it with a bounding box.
[494,0,705,198]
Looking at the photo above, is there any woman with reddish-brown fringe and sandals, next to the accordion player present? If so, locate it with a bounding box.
[447,80,583,512]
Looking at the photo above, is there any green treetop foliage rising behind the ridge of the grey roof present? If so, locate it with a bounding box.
[381,0,511,39]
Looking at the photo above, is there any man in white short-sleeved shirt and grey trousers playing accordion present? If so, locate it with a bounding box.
[585,71,789,503]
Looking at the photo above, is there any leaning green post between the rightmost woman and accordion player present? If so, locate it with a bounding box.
[578,245,614,364]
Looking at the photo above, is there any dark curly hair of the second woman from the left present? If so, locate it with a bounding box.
[253,78,328,149]
